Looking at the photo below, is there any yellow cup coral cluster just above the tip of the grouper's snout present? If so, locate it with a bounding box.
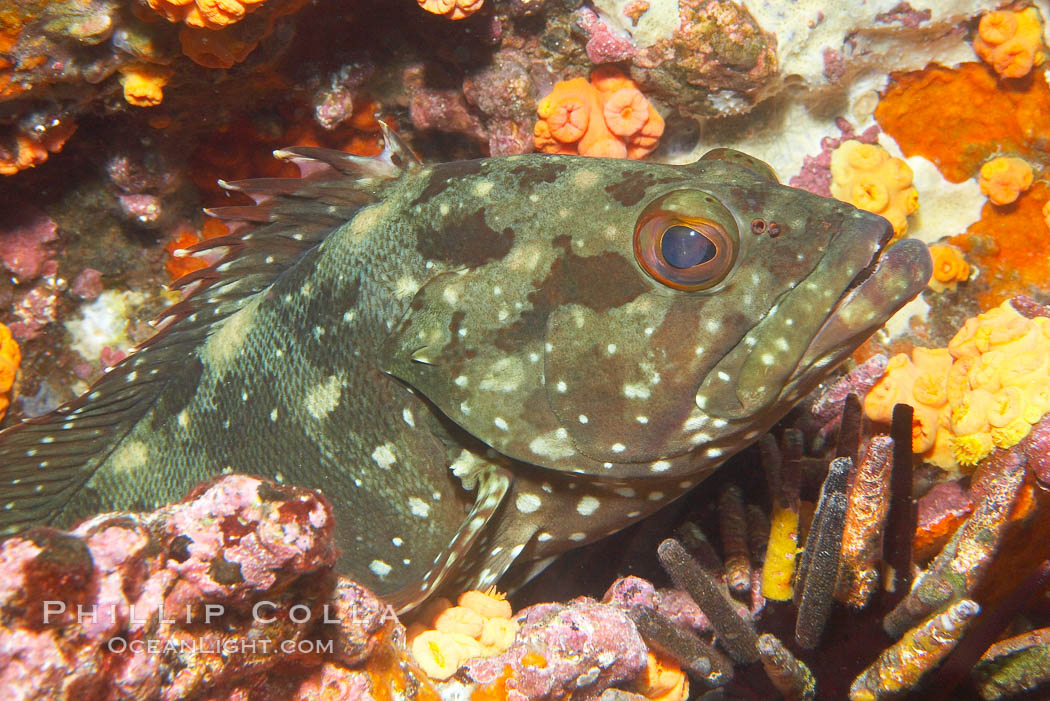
[831,140,919,238]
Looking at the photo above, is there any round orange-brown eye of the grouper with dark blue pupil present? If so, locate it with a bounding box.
[634,190,738,292]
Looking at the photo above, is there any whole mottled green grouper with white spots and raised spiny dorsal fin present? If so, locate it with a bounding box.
[0,132,931,610]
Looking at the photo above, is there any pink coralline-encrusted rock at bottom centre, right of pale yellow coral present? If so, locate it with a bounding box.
[461,597,647,701]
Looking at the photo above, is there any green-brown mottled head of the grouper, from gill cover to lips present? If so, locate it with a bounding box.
[385,149,931,479]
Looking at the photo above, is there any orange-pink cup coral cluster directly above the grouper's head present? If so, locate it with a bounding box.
[532,67,664,160]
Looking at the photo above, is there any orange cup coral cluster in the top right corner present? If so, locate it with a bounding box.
[973,7,1046,78]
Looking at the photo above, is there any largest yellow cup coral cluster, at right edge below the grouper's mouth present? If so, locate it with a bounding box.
[864,301,1050,472]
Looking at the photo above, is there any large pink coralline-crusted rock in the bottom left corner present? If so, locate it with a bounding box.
[0,475,403,701]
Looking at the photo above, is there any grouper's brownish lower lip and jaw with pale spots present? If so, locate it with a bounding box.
[792,232,933,380]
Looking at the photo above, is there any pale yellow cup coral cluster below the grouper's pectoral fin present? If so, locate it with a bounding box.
[408,591,518,680]
